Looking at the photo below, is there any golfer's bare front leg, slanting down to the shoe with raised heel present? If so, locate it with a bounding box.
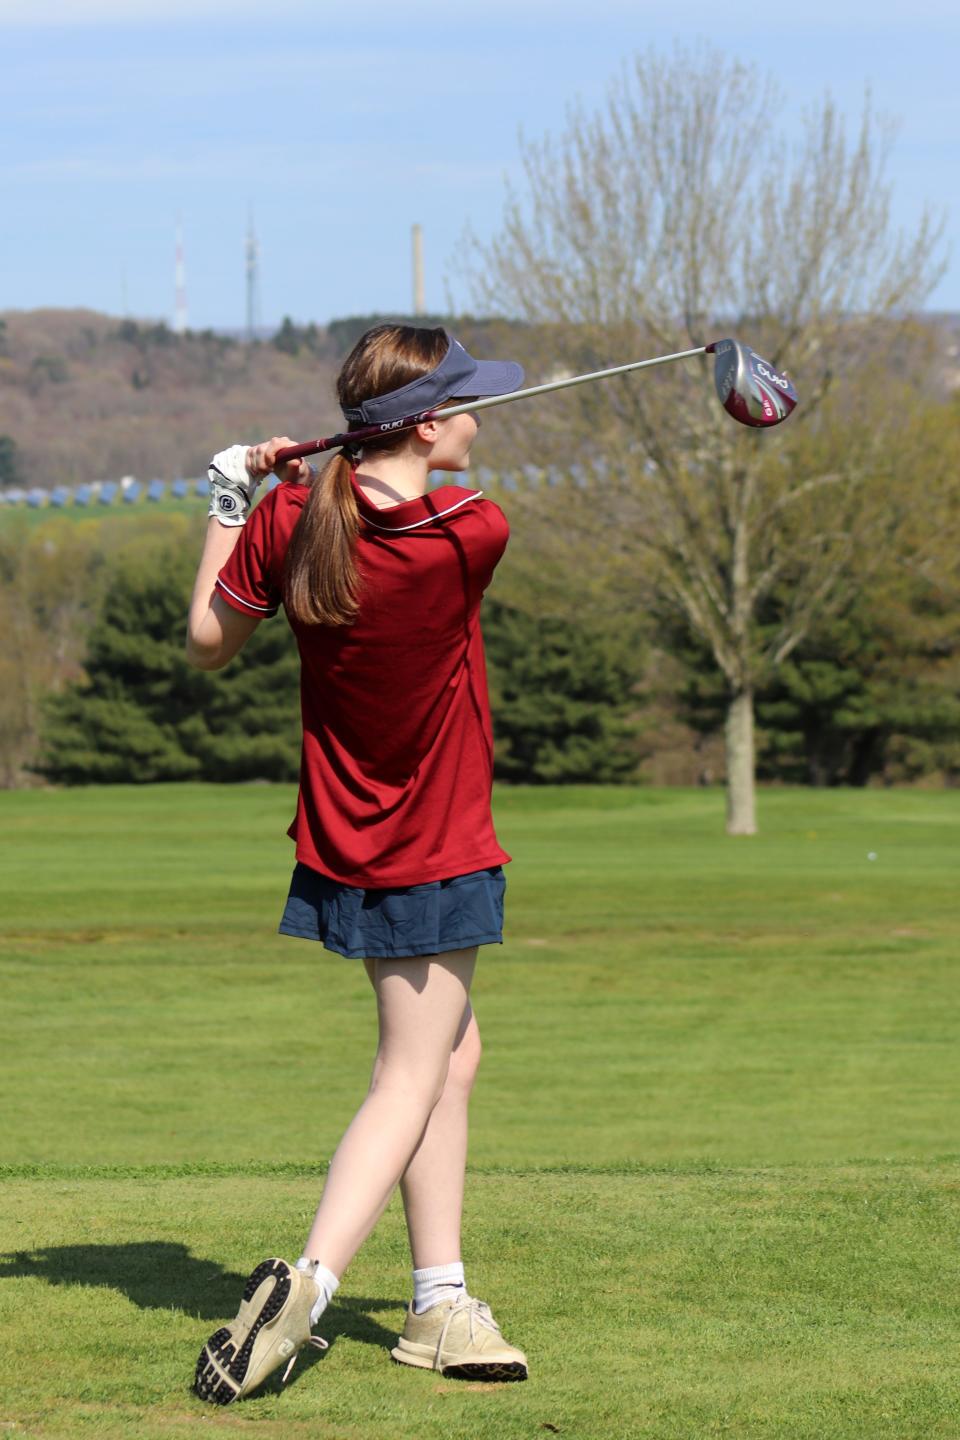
[304,948,476,1276]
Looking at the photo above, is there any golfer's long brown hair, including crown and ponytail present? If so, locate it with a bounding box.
[284,325,449,625]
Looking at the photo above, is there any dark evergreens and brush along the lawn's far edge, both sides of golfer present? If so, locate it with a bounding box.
[0,466,960,786]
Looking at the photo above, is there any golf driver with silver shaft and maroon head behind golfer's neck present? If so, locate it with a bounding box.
[276,340,797,465]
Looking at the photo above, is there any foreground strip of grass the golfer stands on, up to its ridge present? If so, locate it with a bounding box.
[0,1166,960,1440]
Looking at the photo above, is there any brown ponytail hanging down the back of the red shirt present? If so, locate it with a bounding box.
[284,455,360,625]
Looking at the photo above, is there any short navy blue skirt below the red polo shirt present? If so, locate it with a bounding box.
[279,864,507,960]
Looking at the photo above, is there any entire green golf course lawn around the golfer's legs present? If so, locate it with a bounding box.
[0,786,960,1440]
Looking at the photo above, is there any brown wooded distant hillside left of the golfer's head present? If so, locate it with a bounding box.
[0,310,340,488]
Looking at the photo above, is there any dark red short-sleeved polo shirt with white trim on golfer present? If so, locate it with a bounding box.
[211,484,510,888]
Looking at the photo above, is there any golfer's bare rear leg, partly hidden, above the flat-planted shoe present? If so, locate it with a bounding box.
[366,960,481,1270]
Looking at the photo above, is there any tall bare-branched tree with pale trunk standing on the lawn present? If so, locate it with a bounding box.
[469,50,941,835]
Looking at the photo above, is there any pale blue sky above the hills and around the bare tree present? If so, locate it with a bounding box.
[0,0,960,327]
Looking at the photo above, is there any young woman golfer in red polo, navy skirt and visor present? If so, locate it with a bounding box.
[187,325,527,1404]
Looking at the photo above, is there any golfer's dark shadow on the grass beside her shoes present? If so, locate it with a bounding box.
[0,1240,406,1369]
